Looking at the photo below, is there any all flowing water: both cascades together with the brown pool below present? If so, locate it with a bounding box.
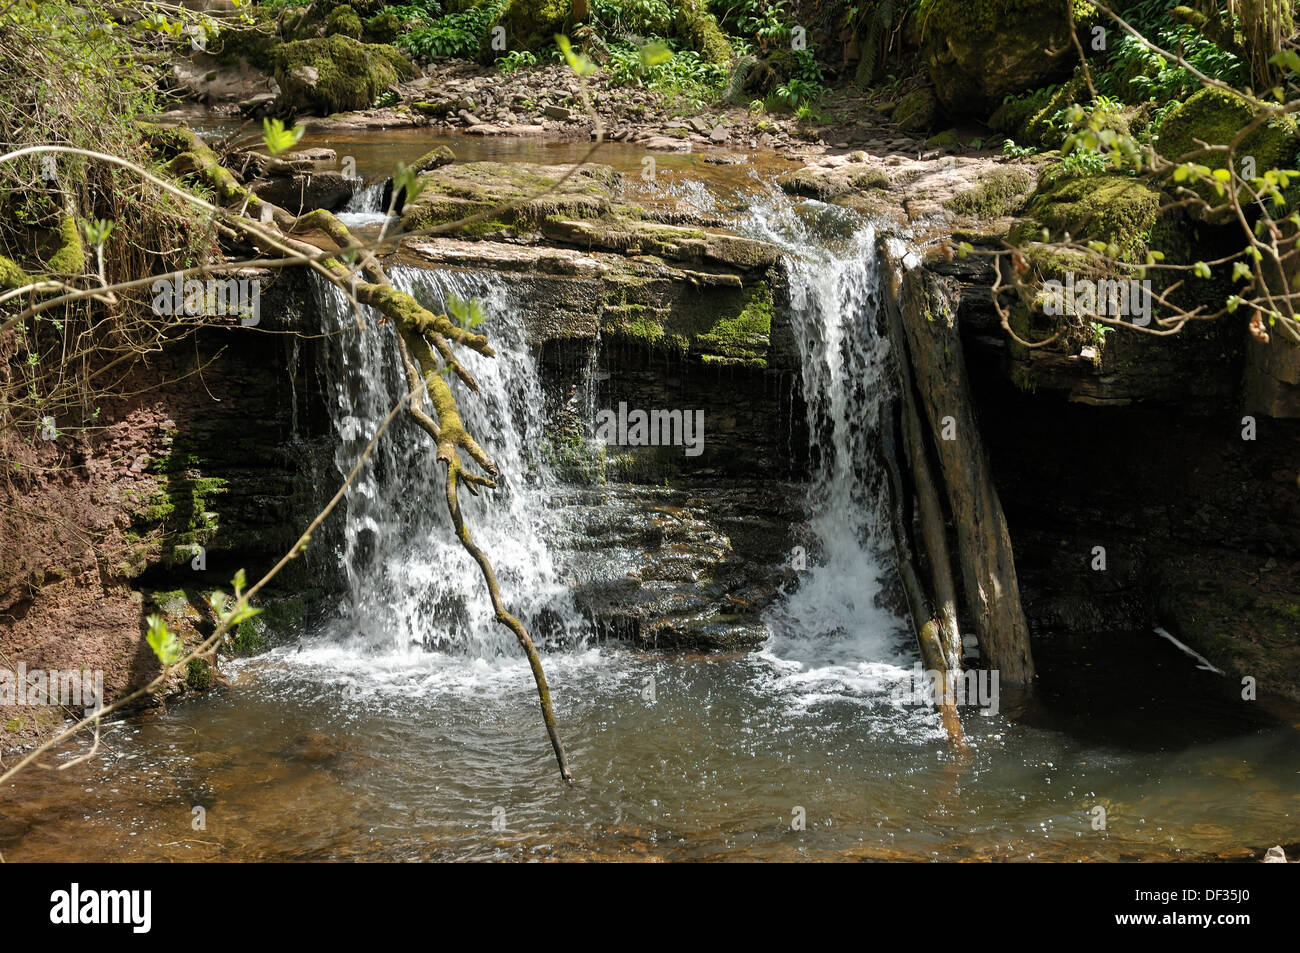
[0,154,1300,859]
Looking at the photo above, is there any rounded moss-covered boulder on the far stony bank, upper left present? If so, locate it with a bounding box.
[274,35,415,116]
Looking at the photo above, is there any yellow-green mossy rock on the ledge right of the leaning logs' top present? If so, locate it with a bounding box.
[1010,174,1162,261]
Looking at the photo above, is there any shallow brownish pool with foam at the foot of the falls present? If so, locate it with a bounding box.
[0,624,1300,861]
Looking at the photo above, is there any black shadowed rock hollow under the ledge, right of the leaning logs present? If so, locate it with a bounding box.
[967,315,1300,699]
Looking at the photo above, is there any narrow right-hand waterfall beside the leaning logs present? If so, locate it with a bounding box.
[744,198,913,693]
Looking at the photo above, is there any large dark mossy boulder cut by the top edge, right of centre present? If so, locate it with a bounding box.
[918,0,1097,116]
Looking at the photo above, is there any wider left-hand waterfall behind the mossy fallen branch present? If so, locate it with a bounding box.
[313,267,582,659]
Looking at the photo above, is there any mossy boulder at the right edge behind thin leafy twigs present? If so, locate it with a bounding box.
[1156,88,1300,220]
